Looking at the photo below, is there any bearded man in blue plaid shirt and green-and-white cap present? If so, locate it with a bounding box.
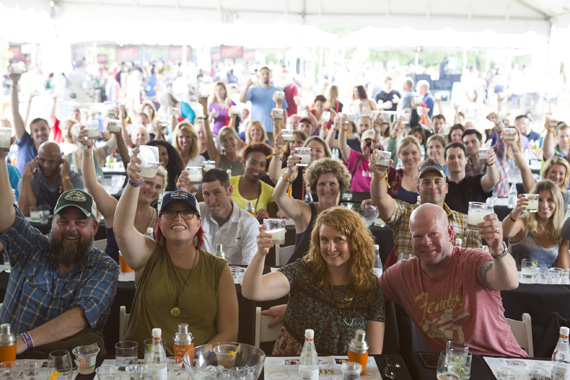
[0,142,119,355]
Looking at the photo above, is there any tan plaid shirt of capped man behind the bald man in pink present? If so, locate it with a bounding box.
[386,199,481,257]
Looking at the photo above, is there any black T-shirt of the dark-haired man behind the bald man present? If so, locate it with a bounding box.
[445,174,493,214]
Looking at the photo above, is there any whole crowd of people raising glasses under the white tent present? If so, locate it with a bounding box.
[0,59,570,356]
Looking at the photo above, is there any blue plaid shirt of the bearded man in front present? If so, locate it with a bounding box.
[0,208,119,334]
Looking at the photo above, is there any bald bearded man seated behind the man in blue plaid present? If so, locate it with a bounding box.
[18,141,85,216]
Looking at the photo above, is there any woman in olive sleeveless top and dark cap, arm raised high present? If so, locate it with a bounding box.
[114,149,238,355]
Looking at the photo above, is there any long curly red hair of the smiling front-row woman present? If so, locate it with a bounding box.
[303,206,378,295]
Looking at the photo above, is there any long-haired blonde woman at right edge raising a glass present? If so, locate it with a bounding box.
[503,179,570,269]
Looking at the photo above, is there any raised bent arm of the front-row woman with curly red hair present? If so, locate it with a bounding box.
[241,226,291,301]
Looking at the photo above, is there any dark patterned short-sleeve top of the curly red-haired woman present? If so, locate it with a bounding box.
[279,259,384,355]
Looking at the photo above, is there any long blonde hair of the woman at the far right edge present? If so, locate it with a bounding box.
[521,179,566,242]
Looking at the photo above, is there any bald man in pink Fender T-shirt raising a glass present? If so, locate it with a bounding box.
[379,204,527,357]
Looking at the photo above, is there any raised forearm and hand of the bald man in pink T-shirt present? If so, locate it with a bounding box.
[477,214,519,290]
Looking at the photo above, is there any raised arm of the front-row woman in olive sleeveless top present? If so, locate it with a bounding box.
[113,148,156,275]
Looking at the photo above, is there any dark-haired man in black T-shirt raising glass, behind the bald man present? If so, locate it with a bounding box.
[444,142,499,214]
